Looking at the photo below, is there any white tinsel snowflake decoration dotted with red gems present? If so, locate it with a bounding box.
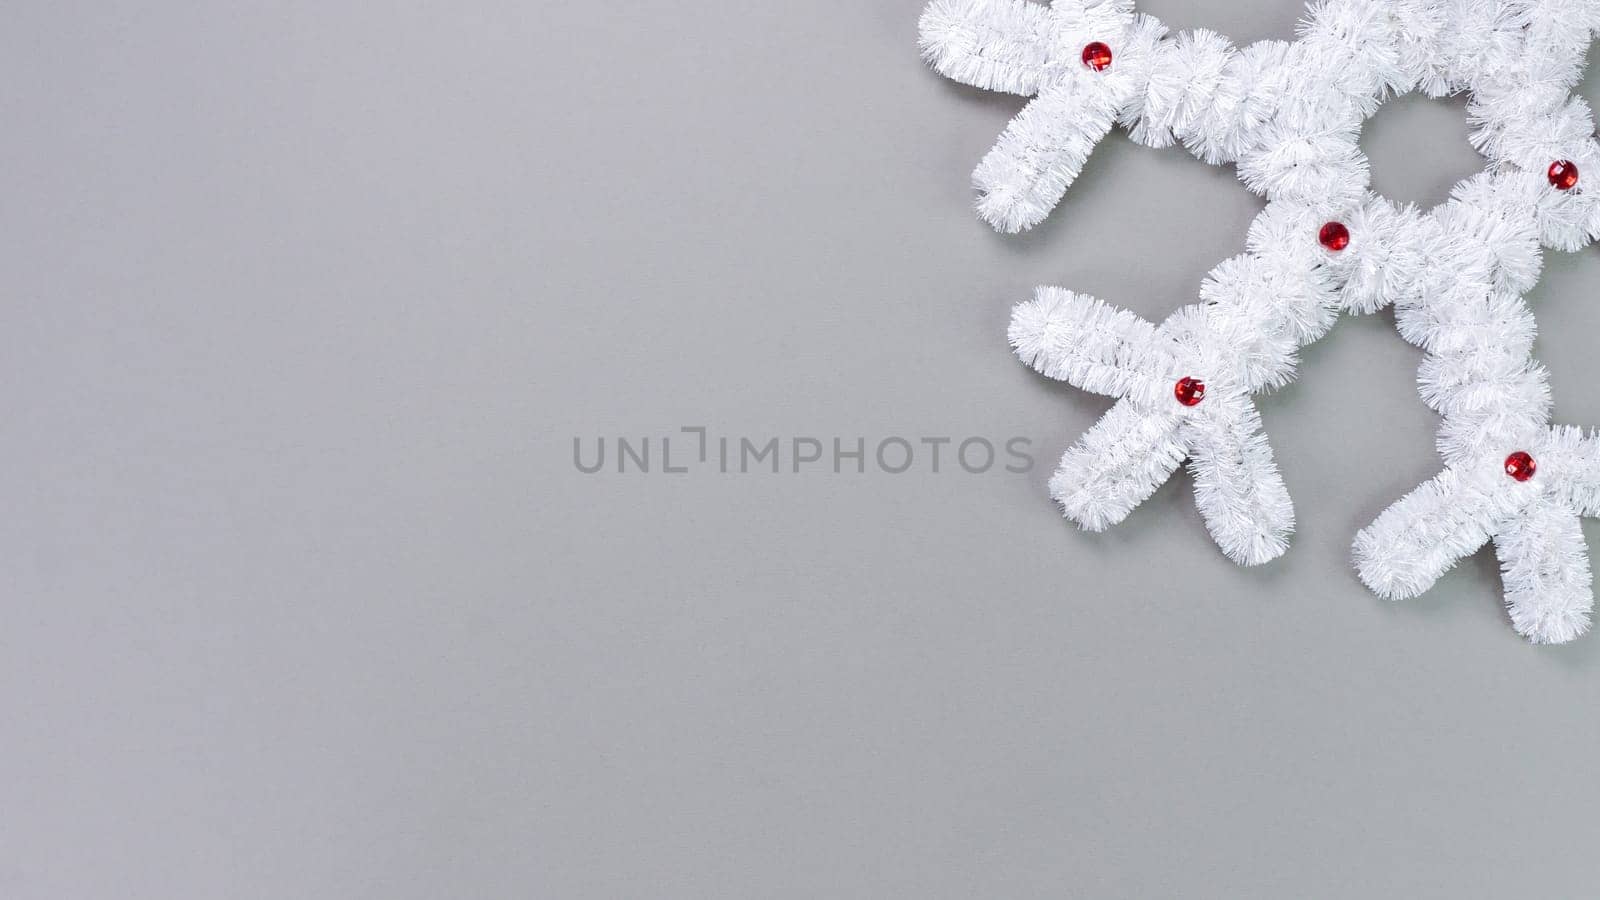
[922,0,1600,642]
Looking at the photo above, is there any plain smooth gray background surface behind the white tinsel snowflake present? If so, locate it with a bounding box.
[9,0,1600,900]
